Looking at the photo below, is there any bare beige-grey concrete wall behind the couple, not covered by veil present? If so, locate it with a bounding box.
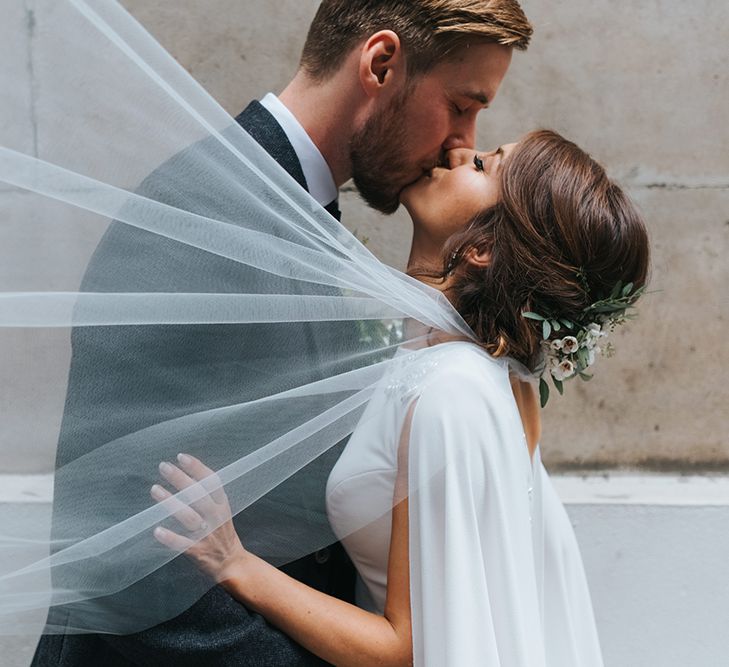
[124,0,729,469]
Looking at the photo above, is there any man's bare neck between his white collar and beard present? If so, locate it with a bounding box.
[279,68,361,188]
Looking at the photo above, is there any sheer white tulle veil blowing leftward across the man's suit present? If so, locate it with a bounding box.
[0,0,484,634]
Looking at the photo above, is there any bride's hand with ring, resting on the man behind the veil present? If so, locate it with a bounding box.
[150,454,249,583]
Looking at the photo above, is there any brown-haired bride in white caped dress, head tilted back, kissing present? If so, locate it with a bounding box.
[151,131,649,667]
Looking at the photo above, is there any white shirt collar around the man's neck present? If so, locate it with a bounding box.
[261,93,339,206]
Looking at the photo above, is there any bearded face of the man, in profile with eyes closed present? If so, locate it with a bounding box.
[350,43,511,214]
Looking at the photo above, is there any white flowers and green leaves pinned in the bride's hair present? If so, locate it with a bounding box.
[522,281,645,407]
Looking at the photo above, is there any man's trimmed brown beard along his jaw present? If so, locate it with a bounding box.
[350,90,420,215]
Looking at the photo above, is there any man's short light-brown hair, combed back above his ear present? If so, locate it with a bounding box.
[301,0,532,81]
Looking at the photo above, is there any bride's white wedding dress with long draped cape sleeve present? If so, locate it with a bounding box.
[327,342,603,667]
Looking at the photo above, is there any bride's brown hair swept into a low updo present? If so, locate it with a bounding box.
[443,130,650,370]
